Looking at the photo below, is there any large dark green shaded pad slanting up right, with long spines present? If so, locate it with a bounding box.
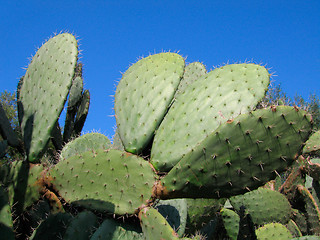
[156,106,312,199]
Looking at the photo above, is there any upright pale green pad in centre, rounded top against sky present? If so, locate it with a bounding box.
[114,52,184,153]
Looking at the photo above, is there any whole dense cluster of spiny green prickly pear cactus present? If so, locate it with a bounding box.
[0,33,320,240]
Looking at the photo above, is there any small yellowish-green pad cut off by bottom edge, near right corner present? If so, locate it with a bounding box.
[256,223,292,240]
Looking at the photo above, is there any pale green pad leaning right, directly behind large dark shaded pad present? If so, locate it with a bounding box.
[151,64,269,172]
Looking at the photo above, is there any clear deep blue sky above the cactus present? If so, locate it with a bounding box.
[0,0,320,137]
